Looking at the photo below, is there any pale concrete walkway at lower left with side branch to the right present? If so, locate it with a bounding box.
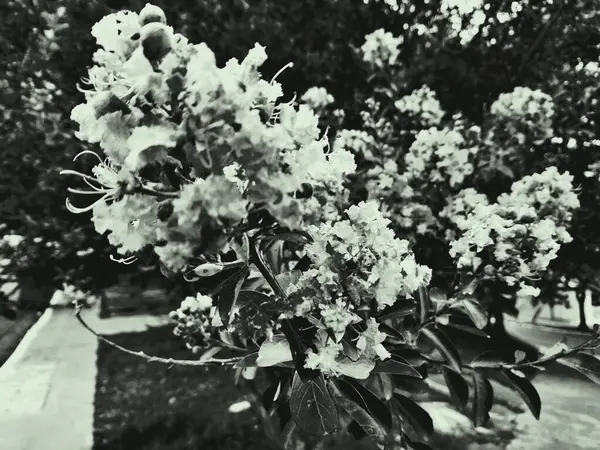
[0,306,166,450]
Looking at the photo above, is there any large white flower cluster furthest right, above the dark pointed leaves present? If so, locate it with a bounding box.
[450,167,579,296]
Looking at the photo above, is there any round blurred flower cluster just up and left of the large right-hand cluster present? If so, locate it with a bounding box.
[404,127,477,187]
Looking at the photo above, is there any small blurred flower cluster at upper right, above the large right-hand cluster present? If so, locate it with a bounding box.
[490,86,554,139]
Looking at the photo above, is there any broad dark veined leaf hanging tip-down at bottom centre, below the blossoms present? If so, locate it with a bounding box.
[290,373,339,436]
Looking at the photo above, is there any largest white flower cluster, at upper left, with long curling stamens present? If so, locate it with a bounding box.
[66,4,356,271]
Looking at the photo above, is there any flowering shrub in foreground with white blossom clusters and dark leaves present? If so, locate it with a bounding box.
[63,4,600,448]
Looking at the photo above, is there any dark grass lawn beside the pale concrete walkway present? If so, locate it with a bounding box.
[93,326,512,450]
